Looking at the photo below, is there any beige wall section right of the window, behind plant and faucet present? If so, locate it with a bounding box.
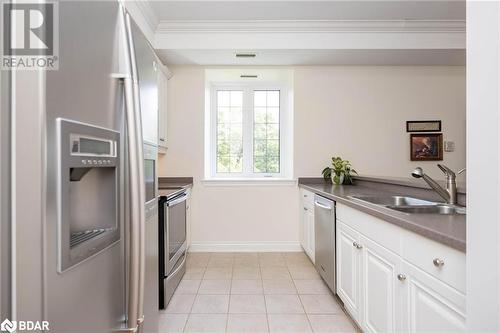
[294,67,465,179]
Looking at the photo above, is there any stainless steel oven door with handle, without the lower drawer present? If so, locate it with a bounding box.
[164,193,187,276]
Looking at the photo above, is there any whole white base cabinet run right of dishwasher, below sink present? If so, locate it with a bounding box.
[337,203,466,332]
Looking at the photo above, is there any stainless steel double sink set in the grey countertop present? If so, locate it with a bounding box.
[350,195,465,215]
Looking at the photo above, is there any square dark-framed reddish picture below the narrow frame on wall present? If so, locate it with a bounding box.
[410,133,443,161]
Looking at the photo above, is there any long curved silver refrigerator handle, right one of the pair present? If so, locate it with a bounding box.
[125,9,146,325]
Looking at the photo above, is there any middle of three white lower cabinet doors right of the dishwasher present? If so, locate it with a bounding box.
[360,235,404,332]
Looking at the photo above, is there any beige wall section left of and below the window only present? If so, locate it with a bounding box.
[159,67,299,250]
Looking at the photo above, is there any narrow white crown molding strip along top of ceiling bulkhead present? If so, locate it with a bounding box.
[156,20,465,34]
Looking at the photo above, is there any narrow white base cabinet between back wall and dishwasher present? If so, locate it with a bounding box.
[300,190,315,263]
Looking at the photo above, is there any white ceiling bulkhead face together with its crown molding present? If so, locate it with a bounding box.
[154,20,466,50]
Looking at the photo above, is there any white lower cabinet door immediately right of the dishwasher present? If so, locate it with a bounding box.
[336,220,361,323]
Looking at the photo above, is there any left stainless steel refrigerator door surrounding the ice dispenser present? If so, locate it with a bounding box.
[45,1,126,333]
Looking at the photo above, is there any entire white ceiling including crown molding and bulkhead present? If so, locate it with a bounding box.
[140,0,465,66]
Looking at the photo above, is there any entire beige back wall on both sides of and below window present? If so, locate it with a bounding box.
[159,66,465,250]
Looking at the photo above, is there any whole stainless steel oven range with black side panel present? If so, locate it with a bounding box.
[159,189,189,309]
